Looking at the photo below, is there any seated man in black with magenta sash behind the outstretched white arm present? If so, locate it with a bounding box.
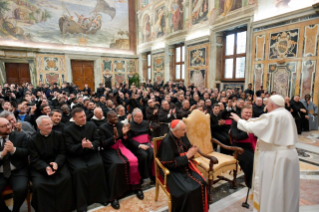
[231,105,259,188]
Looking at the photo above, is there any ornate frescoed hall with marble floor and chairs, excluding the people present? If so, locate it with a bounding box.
[0,0,319,212]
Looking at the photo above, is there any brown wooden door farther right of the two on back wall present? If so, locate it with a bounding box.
[71,60,95,91]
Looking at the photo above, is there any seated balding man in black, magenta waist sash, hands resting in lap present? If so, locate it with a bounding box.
[127,108,154,186]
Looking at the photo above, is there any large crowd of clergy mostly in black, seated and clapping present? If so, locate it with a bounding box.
[0,82,318,212]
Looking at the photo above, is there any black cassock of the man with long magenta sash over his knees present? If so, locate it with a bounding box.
[99,123,141,201]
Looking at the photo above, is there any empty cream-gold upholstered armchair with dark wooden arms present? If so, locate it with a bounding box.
[183,110,243,188]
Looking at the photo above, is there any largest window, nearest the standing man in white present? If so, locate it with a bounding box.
[223,28,247,81]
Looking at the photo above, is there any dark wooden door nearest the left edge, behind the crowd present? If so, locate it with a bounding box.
[5,63,31,85]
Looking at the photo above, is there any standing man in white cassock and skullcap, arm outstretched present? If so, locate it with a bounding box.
[232,95,300,212]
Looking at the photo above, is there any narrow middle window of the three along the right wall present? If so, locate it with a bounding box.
[174,44,185,81]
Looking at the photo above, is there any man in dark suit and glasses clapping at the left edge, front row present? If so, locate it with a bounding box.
[0,118,29,212]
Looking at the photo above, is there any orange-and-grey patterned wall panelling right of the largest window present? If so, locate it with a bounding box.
[250,15,319,104]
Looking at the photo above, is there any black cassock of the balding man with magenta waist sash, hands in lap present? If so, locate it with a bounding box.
[127,121,154,179]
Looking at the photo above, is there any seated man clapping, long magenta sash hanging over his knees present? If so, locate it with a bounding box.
[99,111,144,209]
